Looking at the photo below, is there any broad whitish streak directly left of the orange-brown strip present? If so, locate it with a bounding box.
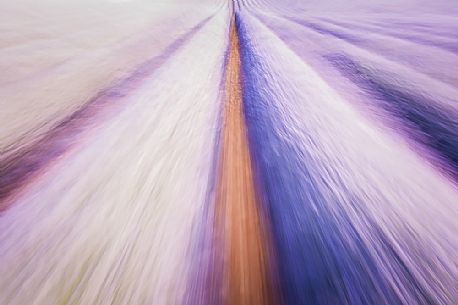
[0,2,227,305]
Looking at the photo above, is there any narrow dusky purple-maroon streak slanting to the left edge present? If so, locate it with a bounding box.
[0,14,212,211]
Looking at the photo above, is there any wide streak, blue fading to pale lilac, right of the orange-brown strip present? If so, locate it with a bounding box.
[237,7,458,304]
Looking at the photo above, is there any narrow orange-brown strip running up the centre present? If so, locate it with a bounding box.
[215,22,272,305]
